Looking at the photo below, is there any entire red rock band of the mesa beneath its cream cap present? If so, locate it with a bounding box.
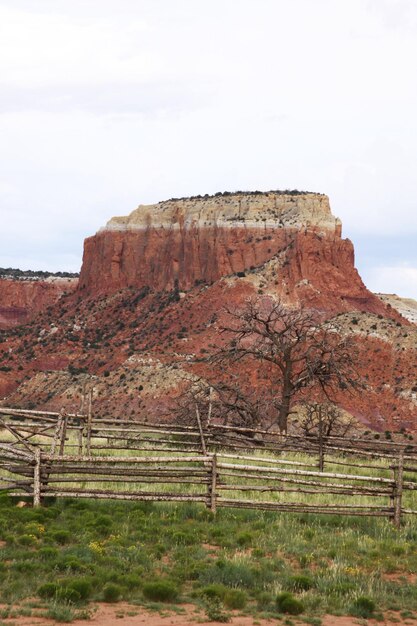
[79,227,386,313]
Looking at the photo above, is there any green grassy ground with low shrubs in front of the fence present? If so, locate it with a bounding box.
[0,496,417,624]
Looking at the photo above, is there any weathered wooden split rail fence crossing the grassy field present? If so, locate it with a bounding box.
[0,399,417,526]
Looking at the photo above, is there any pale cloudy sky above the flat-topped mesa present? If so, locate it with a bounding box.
[0,0,417,298]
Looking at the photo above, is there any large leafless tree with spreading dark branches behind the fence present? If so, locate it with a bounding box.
[212,298,358,433]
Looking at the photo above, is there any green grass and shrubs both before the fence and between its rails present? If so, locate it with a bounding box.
[0,410,417,624]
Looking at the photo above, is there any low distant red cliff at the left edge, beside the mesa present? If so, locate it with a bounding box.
[0,279,77,328]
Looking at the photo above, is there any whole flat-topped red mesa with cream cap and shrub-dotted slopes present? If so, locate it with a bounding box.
[0,192,417,430]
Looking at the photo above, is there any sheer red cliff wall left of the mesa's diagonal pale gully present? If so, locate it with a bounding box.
[80,227,291,293]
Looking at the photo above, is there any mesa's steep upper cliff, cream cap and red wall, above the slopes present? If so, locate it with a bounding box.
[79,192,385,313]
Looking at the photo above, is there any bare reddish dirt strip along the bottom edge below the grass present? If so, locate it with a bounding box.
[0,603,417,626]
